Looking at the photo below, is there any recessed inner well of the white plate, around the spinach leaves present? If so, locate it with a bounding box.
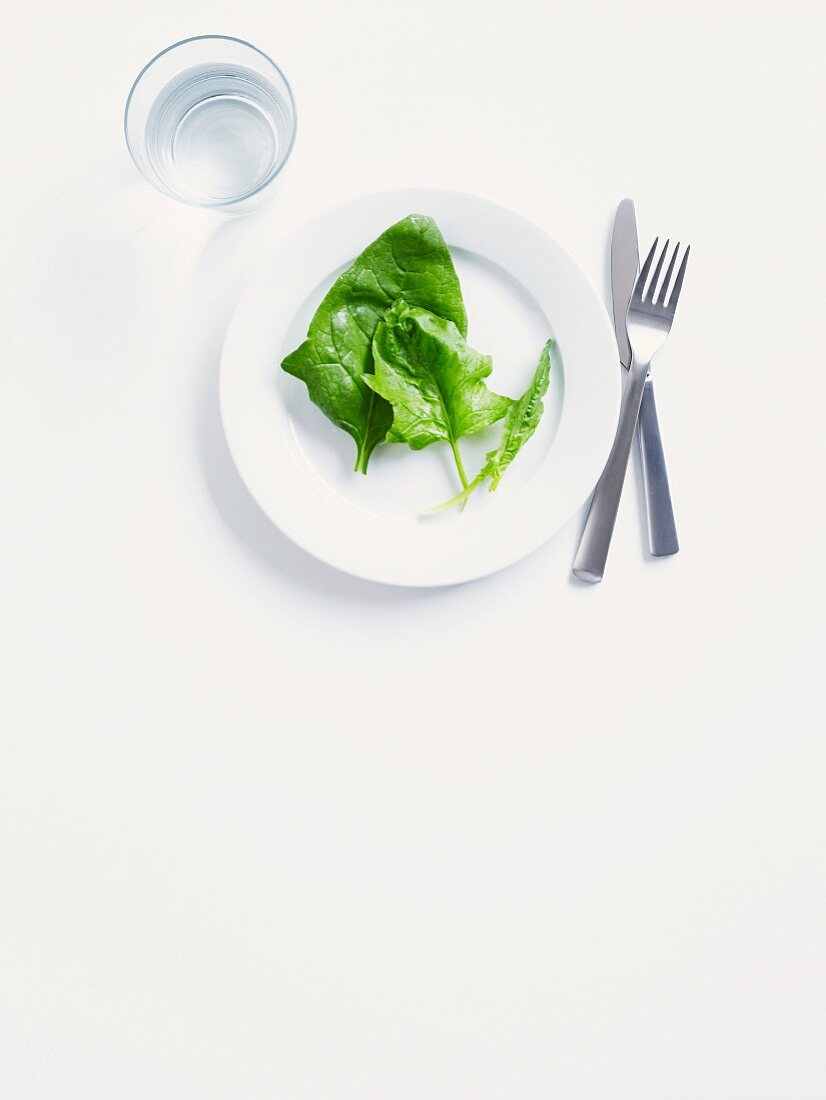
[274,241,564,523]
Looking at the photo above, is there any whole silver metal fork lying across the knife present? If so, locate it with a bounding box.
[573,238,691,584]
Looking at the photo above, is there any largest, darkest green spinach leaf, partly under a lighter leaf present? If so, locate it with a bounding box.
[282,213,467,473]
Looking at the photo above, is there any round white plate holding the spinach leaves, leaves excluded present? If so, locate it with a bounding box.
[220,190,620,586]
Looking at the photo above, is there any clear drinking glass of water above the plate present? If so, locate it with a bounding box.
[123,34,296,213]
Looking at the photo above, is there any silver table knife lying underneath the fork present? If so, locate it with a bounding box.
[610,199,680,558]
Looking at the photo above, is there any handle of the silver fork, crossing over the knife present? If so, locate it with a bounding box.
[573,362,649,584]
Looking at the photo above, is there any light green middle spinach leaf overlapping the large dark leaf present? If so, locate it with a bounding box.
[365,299,511,485]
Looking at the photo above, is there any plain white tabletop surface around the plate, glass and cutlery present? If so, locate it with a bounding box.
[0,0,826,1100]
